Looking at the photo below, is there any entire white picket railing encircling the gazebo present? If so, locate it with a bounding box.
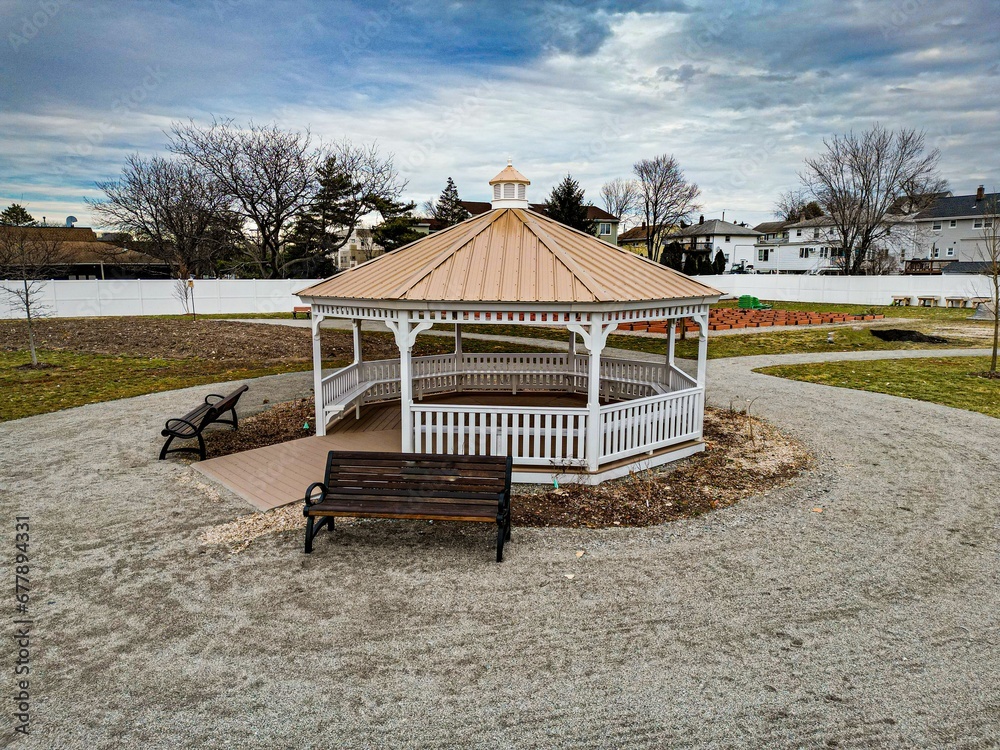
[323,353,704,466]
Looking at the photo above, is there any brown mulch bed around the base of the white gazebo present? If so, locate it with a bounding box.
[207,399,809,528]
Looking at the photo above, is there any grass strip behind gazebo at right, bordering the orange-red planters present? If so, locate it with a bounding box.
[454,322,986,359]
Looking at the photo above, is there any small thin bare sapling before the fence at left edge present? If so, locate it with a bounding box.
[0,216,68,367]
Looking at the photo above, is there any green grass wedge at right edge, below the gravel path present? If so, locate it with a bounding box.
[755,357,1000,418]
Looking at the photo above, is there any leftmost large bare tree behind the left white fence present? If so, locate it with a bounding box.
[87,154,236,278]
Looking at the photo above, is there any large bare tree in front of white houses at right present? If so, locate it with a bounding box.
[800,123,945,274]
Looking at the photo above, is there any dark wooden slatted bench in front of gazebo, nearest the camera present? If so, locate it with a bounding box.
[302,451,513,562]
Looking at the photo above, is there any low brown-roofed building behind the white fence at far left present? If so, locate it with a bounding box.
[0,226,171,280]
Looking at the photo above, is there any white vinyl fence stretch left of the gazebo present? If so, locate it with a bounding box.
[0,279,316,318]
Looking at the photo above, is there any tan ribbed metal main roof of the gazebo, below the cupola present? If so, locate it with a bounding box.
[298,208,721,303]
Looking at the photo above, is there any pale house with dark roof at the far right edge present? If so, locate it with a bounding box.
[910,185,1000,266]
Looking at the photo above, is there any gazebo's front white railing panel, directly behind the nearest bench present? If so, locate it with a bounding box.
[413,404,587,467]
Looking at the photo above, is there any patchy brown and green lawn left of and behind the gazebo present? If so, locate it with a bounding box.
[0,318,545,422]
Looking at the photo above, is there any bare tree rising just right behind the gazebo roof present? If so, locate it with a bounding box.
[633,154,701,260]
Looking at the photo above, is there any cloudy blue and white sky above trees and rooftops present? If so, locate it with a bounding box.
[0,0,1000,225]
